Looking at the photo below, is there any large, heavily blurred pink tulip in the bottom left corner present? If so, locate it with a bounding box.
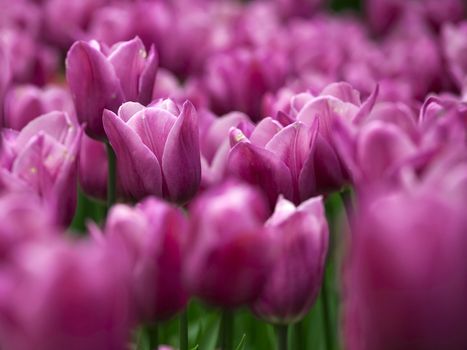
[0,241,134,350]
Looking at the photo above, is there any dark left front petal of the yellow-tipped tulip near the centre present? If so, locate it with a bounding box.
[226,141,293,207]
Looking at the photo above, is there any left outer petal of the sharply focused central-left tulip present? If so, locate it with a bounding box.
[102,110,162,198]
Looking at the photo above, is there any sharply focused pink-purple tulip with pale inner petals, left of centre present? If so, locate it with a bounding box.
[103,99,201,203]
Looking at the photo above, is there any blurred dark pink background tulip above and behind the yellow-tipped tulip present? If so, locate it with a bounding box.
[203,48,288,120]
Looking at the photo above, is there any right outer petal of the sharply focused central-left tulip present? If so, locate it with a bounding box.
[162,101,201,203]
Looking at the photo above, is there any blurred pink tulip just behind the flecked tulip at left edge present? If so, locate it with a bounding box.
[4,85,75,130]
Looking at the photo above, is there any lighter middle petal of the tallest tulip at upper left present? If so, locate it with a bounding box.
[108,37,147,101]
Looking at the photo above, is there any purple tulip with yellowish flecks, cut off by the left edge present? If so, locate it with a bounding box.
[0,112,82,226]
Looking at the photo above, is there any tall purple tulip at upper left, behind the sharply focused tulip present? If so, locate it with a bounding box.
[66,37,157,139]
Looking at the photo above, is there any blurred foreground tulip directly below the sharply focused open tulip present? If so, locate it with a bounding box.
[105,198,187,322]
